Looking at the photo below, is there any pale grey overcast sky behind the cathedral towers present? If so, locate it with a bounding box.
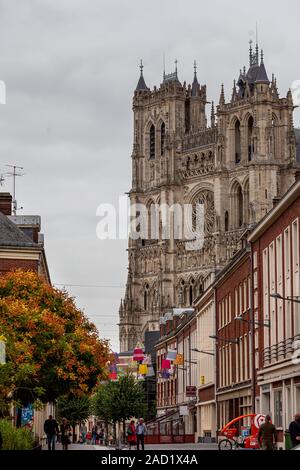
[0,0,300,350]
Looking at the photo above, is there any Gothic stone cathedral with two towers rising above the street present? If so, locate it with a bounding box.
[119,45,299,352]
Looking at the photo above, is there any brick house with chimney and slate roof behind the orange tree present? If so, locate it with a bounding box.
[0,193,50,283]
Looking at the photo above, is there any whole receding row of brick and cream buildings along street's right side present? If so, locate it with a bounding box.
[155,179,300,445]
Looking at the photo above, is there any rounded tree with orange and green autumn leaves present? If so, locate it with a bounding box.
[0,270,111,412]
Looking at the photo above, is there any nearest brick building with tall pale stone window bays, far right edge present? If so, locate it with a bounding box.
[248,180,300,439]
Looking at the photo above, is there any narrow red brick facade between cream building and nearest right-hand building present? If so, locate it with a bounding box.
[214,247,253,429]
